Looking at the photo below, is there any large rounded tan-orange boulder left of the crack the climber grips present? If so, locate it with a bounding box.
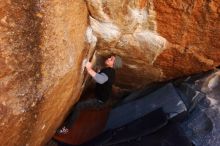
[0,0,88,146]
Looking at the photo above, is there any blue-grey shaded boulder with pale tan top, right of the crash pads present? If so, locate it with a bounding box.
[181,70,220,146]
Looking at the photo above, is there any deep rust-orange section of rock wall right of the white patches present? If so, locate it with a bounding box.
[154,0,220,79]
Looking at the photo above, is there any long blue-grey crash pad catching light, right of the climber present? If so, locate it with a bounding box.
[105,83,186,130]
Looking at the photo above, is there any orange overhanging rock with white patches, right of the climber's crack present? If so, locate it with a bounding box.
[87,0,220,88]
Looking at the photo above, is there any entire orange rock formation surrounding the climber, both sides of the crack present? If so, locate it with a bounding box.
[0,0,220,146]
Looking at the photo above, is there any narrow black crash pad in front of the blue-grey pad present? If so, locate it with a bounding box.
[102,108,168,145]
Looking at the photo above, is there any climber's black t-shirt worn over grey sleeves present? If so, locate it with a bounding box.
[95,67,115,102]
